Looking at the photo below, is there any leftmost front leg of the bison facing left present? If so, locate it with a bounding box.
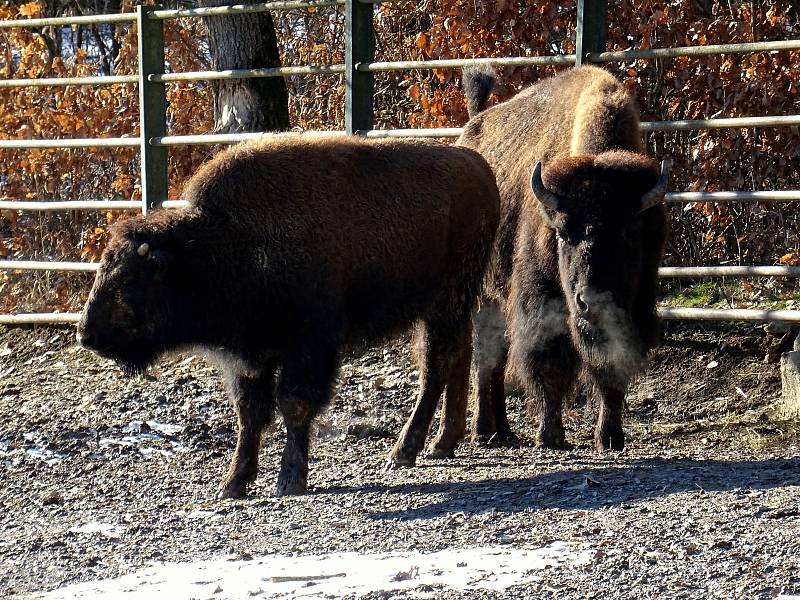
[217,362,277,498]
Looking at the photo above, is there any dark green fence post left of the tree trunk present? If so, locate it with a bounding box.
[136,5,169,213]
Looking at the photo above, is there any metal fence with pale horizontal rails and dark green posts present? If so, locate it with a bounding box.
[0,0,800,324]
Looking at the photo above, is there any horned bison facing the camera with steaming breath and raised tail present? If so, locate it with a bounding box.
[432,67,669,451]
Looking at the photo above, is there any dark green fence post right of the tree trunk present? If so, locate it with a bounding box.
[344,0,375,134]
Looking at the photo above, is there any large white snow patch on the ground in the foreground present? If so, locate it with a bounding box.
[31,541,591,600]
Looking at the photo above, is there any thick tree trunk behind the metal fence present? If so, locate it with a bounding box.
[198,0,290,133]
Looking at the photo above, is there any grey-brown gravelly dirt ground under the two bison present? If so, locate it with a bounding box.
[0,323,800,599]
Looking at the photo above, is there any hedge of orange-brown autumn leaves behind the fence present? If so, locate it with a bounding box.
[0,0,800,312]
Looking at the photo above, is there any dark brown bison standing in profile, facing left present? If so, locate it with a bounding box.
[78,135,499,497]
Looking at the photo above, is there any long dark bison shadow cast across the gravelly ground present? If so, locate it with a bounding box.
[315,458,800,521]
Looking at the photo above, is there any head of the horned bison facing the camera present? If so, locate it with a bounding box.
[531,151,669,374]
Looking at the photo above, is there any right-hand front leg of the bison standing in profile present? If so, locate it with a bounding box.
[276,336,338,496]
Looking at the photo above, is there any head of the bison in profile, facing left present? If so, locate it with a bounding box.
[77,214,180,373]
